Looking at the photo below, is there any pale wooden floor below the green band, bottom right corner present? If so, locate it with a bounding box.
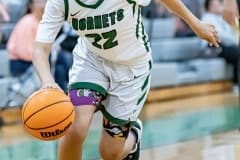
[141,130,240,160]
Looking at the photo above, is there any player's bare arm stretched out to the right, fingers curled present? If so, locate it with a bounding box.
[159,0,219,47]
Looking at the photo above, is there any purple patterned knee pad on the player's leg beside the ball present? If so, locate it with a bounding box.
[69,89,102,106]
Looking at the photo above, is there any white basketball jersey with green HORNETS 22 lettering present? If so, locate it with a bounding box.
[37,0,151,64]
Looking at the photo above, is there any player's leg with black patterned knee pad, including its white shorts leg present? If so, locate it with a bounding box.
[100,60,151,160]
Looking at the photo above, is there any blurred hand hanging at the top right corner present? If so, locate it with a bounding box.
[223,0,239,26]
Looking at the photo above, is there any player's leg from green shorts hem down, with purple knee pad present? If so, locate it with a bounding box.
[59,82,106,160]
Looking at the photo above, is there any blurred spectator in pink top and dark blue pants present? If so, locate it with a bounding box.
[7,0,46,76]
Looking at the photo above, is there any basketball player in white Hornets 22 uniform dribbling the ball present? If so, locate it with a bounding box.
[33,0,219,160]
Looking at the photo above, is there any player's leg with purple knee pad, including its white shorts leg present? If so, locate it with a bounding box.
[59,47,108,160]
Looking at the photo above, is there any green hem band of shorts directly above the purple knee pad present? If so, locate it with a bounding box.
[69,82,107,97]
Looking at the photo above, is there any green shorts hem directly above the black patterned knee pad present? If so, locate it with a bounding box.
[101,108,136,126]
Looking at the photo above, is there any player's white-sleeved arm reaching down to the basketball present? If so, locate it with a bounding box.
[33,0,65,88]
